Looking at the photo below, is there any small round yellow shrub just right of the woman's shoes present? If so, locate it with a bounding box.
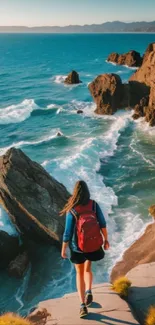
[112,277,131,298]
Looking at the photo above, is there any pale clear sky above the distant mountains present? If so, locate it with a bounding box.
[0,0,155,26]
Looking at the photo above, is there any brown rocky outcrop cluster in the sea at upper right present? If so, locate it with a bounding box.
[89,43,155,126]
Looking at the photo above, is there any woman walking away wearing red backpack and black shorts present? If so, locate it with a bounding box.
[60,181,109,318]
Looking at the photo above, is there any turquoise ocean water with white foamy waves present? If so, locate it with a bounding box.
[0,34,155,313]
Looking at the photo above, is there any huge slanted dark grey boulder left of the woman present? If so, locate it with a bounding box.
[0,148,69,244]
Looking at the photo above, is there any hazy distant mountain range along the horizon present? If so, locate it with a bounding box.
[0,21,155,33]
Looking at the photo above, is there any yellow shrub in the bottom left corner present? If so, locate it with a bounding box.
[0,313,32,325]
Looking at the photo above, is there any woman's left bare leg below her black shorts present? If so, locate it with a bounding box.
[75,263,85,304]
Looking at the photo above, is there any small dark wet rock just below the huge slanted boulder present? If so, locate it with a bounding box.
[8,252,29,278]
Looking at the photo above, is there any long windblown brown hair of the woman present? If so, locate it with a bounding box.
[60,181,90,216]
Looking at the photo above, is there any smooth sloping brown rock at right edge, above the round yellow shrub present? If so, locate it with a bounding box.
[111,223,155,282]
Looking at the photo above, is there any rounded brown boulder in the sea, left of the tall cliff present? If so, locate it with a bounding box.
[89,73,124,115]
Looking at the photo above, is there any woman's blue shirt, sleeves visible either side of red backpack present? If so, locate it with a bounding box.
[63,203,106,253]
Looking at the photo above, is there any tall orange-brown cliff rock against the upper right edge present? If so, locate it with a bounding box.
[130,43,155,126]
